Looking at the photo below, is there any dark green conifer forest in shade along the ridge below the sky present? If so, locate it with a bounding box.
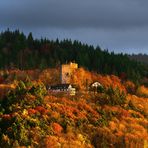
[0,29,148,81]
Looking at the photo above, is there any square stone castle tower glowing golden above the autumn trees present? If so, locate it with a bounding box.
[60,62,78,84]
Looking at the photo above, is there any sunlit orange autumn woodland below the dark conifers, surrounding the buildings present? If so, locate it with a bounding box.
[0,68,148,148]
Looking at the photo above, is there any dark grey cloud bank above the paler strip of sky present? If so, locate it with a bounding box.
[0,0,148,29]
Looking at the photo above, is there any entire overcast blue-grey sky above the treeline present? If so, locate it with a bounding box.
[0,0,148,54]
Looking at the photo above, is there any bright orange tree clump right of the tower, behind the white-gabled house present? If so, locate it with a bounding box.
[71,68,126,92]
